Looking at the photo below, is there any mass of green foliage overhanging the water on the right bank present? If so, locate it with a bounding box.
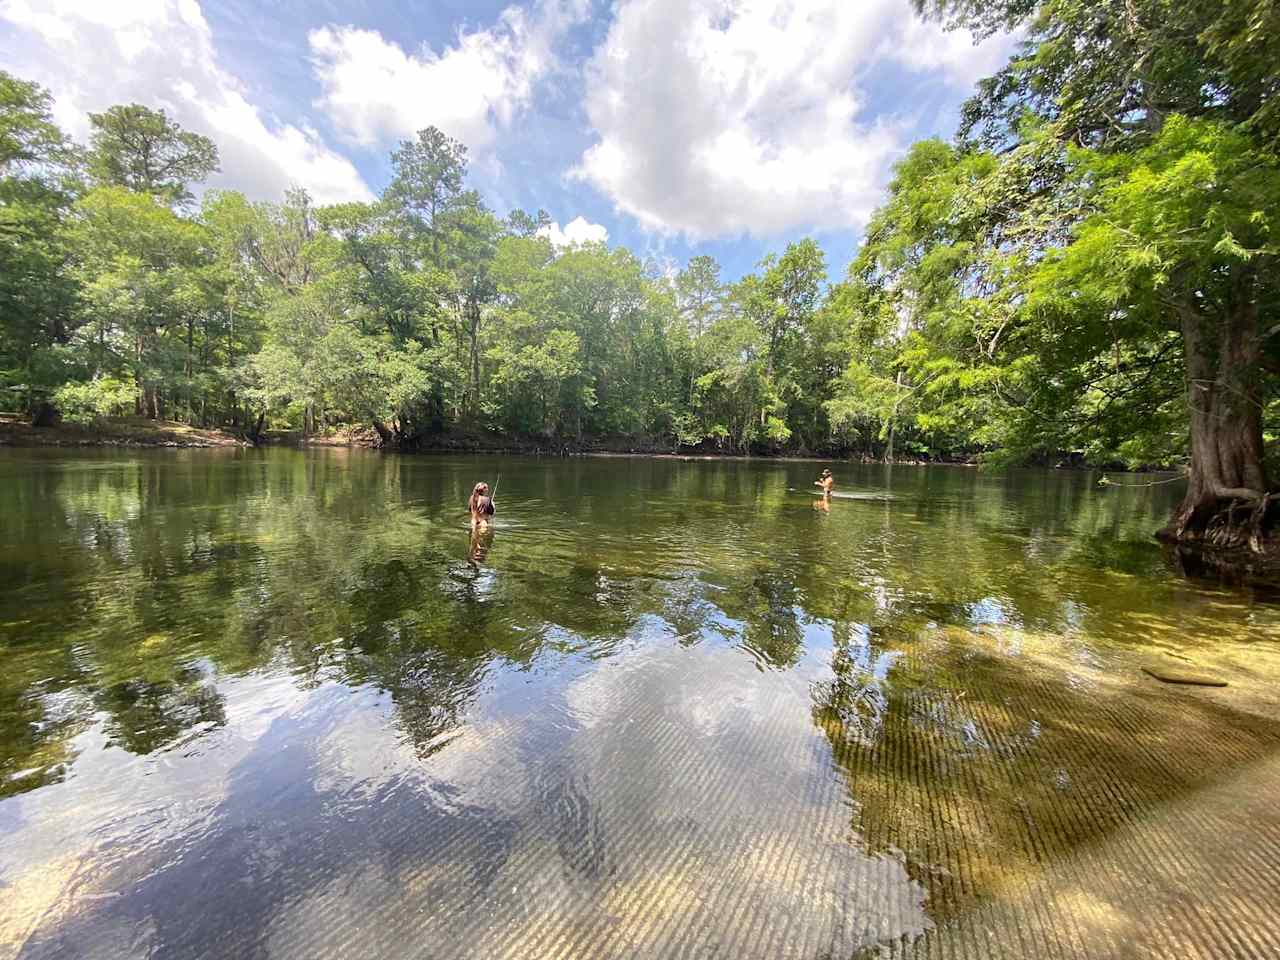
[885,0,1280,499]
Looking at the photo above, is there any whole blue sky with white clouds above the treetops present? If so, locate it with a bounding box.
[0,0,1010,278]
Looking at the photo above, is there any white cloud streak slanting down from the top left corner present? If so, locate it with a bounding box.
[0,0,372,202]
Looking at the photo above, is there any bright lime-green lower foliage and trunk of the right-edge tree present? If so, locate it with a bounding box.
[1029,115,1280,539]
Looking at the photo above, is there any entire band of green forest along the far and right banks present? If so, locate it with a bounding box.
[0,0,1280,550]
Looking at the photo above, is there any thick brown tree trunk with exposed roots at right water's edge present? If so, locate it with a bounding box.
[1158,288,1268,550]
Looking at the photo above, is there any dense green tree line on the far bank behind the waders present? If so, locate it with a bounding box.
[0,77,855,452]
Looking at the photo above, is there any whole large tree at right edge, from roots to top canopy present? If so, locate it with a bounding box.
[896,0,1276,549]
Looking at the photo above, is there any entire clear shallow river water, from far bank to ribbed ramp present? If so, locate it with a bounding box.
[0,451,1280,957]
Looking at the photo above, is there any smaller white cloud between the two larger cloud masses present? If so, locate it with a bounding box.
[307,0,588,150]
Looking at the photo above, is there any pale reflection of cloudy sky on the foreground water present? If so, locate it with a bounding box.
[0,639,929,956]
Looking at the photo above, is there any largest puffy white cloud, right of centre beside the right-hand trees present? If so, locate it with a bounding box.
[571,0,1007,239]
